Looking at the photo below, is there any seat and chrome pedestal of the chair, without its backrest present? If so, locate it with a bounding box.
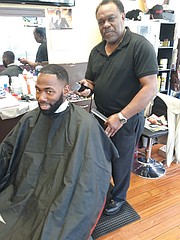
[132,128,168,178]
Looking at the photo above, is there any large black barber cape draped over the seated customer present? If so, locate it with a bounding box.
[0,103,118,240]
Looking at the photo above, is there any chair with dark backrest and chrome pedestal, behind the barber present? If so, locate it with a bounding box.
[132,97,168,179]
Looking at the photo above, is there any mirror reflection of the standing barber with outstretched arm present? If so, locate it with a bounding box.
[19,27,48,68]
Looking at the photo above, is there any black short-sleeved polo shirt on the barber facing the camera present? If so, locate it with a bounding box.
[85,28,158,114]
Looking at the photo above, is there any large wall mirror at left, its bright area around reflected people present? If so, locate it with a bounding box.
[0,8,45,65]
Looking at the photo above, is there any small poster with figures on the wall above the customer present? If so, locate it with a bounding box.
[48,8,72,30]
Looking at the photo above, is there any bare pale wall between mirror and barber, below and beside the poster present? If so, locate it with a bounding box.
[47,0,101,63]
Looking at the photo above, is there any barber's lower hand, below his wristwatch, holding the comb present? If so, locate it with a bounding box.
[105,113,123,137]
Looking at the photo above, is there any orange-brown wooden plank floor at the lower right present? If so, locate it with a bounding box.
[98,144,180,240]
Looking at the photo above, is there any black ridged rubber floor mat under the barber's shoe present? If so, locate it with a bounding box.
[92,202,140,240]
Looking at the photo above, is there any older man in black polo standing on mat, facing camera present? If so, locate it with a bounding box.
[80,0,158,215]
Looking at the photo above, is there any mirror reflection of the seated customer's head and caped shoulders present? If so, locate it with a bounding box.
[0,51,23,81]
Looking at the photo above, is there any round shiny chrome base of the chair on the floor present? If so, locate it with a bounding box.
[132,158,166,179]
